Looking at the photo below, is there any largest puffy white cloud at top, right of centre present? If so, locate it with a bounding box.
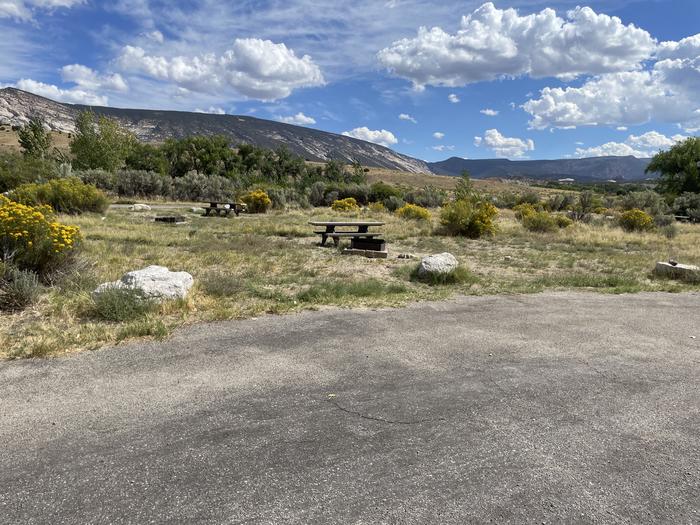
[377,2,656,89]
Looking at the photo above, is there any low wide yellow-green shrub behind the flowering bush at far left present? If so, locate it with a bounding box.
[9,177,109,214]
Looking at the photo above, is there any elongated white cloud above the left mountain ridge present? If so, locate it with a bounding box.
[117,38,325,100]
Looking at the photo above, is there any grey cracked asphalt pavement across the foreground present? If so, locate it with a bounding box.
[0,293,700,524]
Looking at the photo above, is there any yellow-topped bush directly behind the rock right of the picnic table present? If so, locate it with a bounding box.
[440,198,498,239]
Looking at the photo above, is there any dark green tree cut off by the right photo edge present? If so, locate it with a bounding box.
[645,137,700,195]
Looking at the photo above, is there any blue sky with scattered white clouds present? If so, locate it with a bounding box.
[0,0,700,161]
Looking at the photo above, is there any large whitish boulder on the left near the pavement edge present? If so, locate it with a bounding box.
[93,266,194,300]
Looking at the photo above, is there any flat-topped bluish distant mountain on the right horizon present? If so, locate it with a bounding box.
[428,156,651,181]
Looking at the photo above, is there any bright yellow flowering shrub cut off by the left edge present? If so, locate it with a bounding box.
[0,195,81,275]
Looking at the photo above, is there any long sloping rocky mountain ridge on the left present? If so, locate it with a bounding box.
[0,88,430,173]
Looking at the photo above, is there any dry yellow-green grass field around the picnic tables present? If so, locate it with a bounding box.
[0,203,700,357]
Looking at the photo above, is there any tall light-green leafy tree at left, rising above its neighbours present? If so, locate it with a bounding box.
[70,110,136,171]
